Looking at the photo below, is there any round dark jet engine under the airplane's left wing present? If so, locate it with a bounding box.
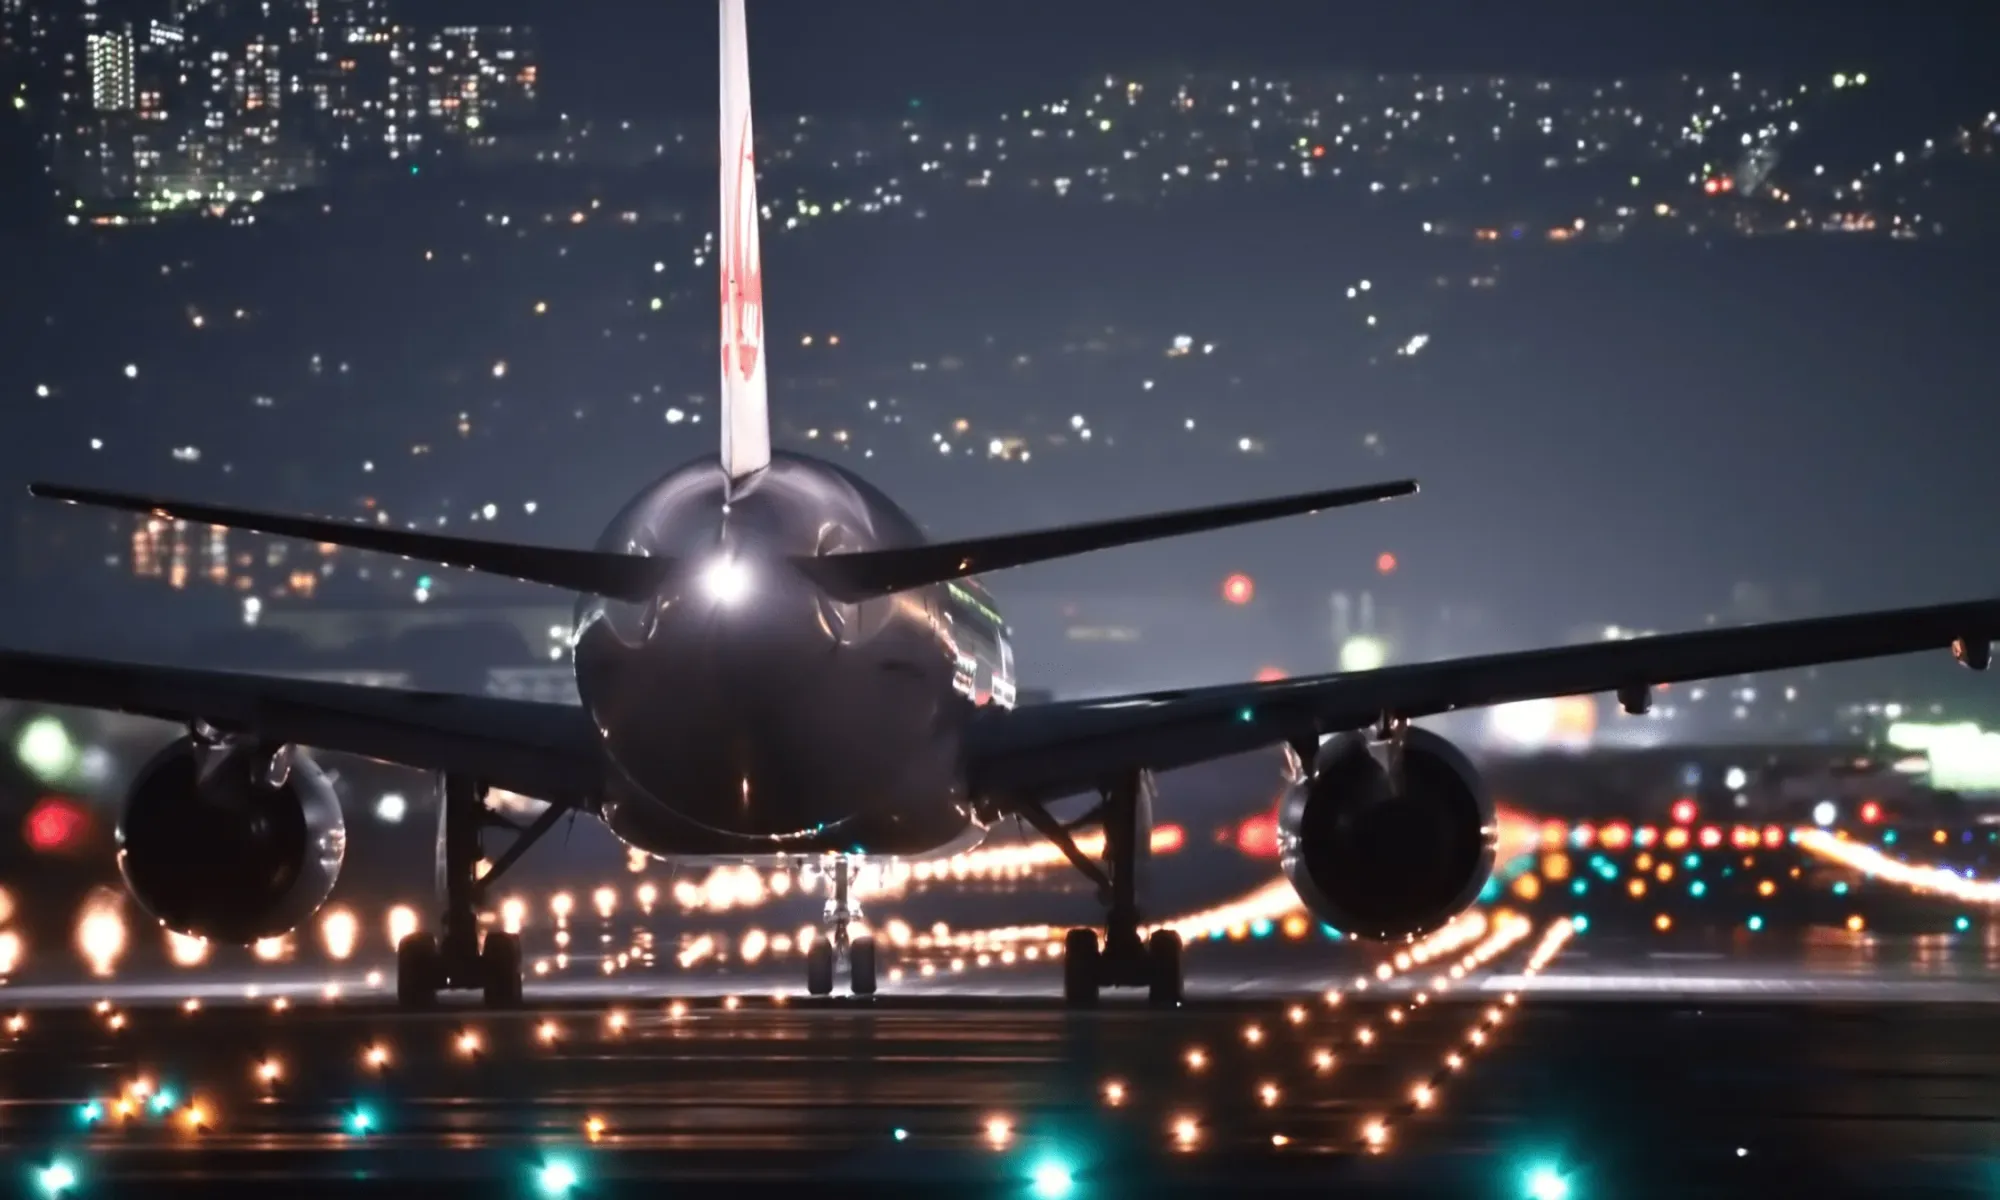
[118,738,348,946]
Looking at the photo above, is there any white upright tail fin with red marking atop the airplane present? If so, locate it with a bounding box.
[716,0,770,482]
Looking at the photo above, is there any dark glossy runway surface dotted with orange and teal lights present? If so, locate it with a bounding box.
[0,916,2000,1200]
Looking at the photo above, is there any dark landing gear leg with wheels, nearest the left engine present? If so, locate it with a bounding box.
[396,774,564,1008]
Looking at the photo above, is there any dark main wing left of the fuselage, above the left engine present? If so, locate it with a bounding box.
[0,650,604,806]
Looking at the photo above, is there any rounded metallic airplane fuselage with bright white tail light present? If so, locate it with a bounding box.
[572,454,1014,858]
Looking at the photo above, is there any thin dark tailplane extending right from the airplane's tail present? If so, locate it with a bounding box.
[794,480,1416,602]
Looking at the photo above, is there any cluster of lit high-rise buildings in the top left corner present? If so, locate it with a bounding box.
[0,0,538,226]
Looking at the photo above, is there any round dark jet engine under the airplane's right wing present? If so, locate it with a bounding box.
[1278,728,1498,940]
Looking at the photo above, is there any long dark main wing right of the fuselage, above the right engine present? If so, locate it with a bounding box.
[966,600,2000,798]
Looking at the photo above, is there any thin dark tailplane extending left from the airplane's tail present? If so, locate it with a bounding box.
[28,484,672,600]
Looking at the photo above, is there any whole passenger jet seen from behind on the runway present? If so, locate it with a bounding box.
[0,0,2000,1008]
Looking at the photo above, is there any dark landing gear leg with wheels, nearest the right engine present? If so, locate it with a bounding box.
[1022,772,1186,1008]
